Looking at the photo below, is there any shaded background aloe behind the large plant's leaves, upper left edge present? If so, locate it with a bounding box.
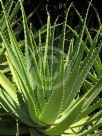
[0,0,19,73]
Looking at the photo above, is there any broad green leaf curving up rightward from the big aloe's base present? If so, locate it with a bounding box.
[44,100,83,135]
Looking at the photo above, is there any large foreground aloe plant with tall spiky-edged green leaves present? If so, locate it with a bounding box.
[0,0,102,136]
